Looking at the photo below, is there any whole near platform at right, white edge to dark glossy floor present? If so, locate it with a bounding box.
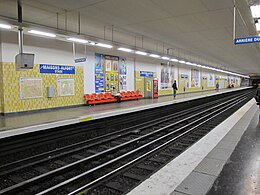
[127,94,260,195]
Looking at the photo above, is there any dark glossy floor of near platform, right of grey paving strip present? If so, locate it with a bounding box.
[208,105,260,195]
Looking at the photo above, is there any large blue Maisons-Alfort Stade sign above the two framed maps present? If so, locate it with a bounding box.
[40,64,75,74]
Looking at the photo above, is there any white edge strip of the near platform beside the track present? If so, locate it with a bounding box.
[127,99,255,195]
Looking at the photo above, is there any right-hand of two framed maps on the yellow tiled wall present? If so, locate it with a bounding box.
[57,78,74,96]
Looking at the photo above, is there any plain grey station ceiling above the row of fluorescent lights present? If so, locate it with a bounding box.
[0,0,260,74]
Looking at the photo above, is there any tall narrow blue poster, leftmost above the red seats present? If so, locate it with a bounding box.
[95,54,105,93]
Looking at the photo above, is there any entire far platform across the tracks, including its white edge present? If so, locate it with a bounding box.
[0,87,250,139]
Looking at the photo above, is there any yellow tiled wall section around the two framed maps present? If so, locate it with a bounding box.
[3,63,85,113]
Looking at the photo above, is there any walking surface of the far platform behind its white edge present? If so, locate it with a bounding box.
[0,88,244,134]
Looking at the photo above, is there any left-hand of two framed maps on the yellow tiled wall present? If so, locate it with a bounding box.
[20,78,43,99]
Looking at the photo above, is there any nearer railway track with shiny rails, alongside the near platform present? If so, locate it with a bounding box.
[0,91,252,194]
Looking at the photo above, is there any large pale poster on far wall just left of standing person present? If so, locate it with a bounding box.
[160,64,176,89]
